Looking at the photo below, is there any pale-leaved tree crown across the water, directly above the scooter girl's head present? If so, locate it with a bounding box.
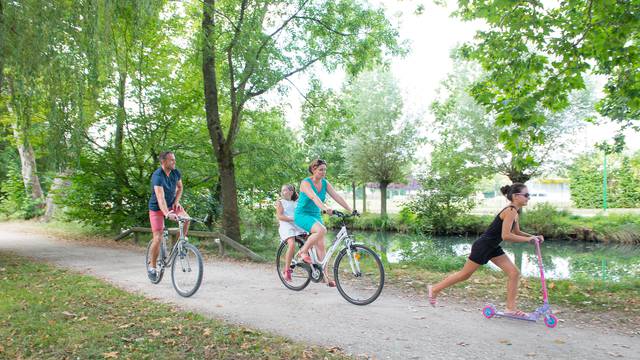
[431,57,595,183]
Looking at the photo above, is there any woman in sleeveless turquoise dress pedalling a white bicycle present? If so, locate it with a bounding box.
[294,159,352,287]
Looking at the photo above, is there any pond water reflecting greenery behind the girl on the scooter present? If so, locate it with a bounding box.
[348,232,640,281]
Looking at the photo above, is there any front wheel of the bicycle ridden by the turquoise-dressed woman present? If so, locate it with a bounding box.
[333,244,384,305]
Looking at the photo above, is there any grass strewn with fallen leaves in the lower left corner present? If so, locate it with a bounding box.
[0,253,346,359]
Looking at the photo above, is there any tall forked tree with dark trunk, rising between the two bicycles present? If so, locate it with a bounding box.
[202,0,398,239]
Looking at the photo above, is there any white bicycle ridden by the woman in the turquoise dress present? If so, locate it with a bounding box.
[276,211,384,305]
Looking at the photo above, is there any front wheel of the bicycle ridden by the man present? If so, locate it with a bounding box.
[171,242,204,297]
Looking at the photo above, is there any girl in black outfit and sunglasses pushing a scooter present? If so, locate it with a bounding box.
[427,183,544,317]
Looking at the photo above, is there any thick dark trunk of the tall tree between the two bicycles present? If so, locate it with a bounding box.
[202,0,242,241]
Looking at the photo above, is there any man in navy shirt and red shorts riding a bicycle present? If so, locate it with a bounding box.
[147,151,189,280]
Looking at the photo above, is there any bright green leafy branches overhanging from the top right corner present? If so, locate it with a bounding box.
[456,0,640,160]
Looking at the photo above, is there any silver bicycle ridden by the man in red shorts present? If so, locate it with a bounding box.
[145,216,203,297]
